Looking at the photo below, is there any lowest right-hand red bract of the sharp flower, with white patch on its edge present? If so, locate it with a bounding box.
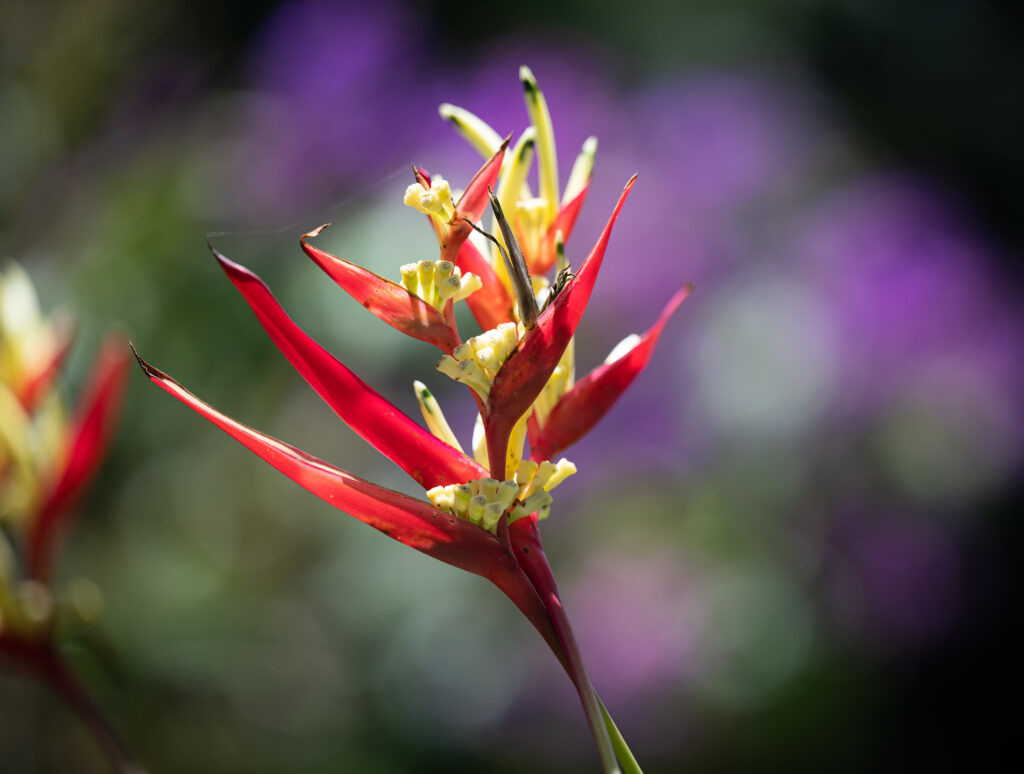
[530,285,692,461]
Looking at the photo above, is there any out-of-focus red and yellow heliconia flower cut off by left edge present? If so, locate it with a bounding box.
[0,267,138,772]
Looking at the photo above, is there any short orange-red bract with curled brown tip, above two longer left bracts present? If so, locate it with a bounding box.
[302,229,462,354]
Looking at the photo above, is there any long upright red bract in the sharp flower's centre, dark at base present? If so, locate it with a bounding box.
[484,175,636,478]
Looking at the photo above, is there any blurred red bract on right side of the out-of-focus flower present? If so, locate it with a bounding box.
[28,335,129,579]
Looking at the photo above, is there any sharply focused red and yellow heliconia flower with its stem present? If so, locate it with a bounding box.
[136,68,689,772]
